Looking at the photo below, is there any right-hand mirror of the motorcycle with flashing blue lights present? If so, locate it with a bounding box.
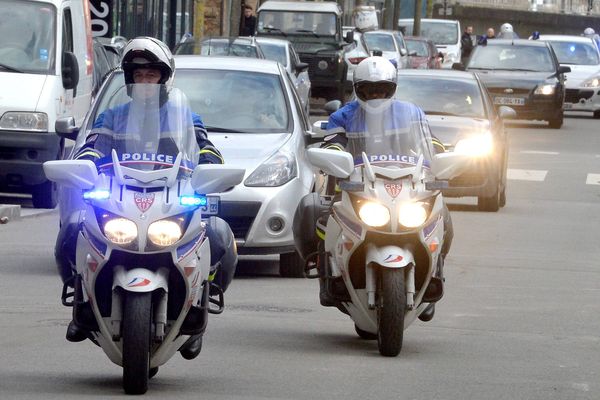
[192,164,246,194]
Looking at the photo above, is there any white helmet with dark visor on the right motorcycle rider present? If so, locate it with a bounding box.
[353,56,397,112]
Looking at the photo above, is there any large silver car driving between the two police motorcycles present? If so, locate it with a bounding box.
[174,56,315,277]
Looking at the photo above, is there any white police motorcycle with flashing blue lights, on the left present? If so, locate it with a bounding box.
[44,84,245,394]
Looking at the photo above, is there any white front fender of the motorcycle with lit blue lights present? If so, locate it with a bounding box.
[113,265,169,293]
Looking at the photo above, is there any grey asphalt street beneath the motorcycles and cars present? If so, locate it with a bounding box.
[0,114,600,400]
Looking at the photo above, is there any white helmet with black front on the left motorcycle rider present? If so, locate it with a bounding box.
[121,36,175,87]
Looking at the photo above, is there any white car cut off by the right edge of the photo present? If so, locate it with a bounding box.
[540,35,600,118]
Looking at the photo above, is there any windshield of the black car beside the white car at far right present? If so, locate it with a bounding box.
[467,44,555,72]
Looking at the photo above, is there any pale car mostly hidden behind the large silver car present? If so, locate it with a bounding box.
[256,36,310,115]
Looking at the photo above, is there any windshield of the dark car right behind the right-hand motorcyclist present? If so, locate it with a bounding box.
[395,75,486,118]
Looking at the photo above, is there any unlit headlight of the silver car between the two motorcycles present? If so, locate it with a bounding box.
[244,151,296,187]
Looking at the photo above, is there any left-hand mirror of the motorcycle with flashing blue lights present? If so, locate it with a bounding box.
[44,160,98,190]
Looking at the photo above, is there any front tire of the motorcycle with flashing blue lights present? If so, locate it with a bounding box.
[122,292,152,394]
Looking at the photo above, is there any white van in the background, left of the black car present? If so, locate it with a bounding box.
[398,18,462,68]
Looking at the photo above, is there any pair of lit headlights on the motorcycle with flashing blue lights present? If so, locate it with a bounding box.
[99,213,187,247]
